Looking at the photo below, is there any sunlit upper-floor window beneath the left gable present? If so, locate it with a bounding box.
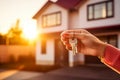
[42,12,61,28]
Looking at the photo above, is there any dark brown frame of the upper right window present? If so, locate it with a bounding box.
[87,0,115,21]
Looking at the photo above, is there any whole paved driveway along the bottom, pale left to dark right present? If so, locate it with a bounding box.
[0,66,120,80]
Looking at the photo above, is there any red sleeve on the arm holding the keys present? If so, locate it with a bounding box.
[101,45,120,74]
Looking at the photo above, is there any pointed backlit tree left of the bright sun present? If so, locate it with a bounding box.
[6,19,27,44]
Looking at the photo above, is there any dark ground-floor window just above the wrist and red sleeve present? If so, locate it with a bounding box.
[98,35,117,47]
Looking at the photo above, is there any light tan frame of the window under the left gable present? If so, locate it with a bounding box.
[42,11,62,28]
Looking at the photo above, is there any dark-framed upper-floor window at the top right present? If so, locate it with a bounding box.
[87,0,114,20]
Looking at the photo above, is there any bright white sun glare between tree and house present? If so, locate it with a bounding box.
[21,20,37,40]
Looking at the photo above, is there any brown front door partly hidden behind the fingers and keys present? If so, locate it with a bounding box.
[55,39,69,67]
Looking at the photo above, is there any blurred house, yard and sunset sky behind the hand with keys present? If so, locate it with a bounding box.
[0,0,120,80]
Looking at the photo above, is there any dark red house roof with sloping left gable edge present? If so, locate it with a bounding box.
[33,0,85,18]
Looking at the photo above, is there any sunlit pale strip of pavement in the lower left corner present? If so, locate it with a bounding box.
[0,70,43,80]
